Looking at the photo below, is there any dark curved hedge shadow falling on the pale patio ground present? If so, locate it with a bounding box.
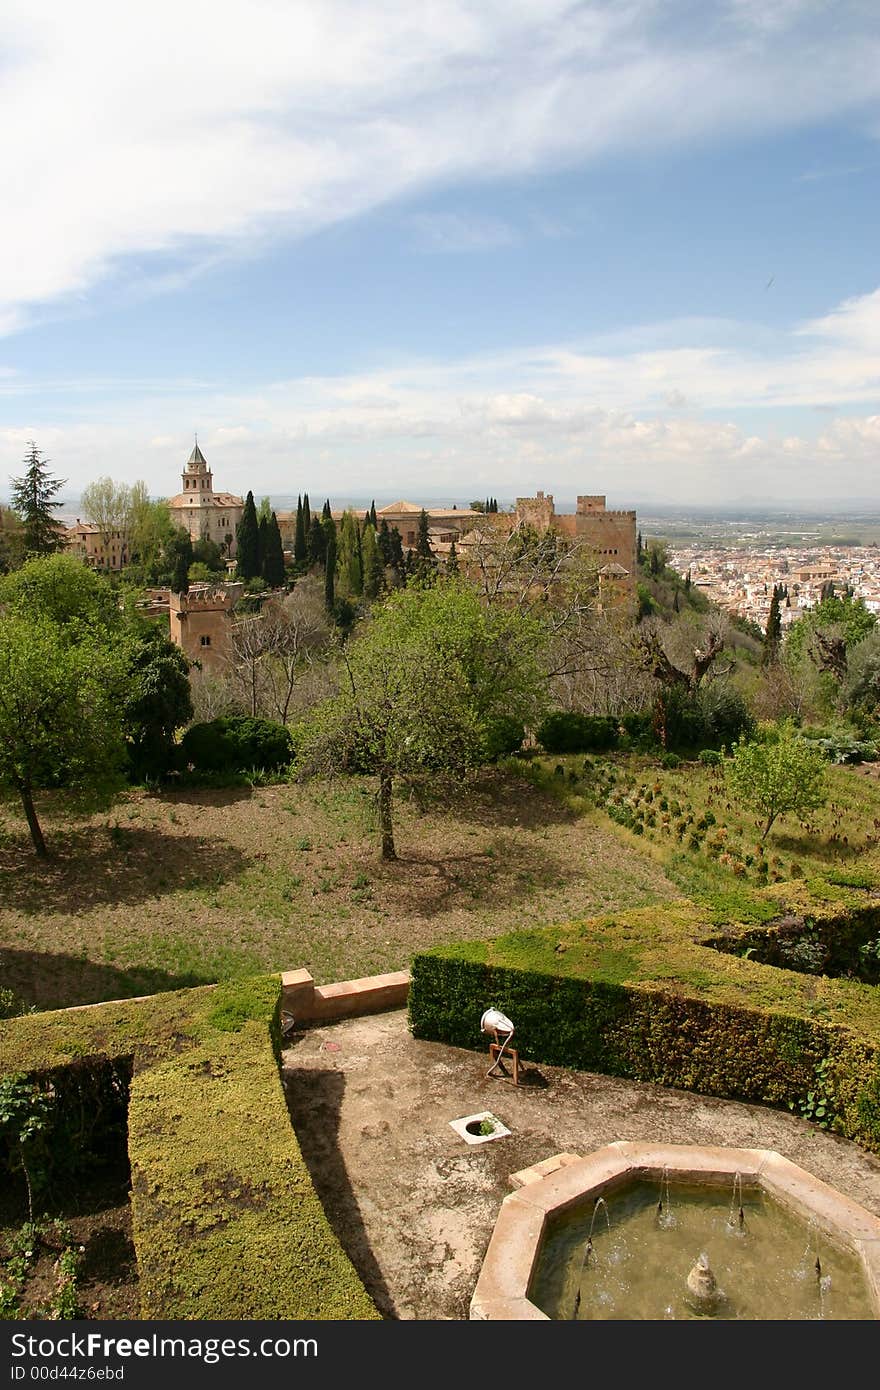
[282,1068,396,1318]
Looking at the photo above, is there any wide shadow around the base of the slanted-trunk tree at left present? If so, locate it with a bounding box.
[0,826,247,916]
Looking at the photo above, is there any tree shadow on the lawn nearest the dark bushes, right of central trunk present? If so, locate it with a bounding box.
[398,769,581,830]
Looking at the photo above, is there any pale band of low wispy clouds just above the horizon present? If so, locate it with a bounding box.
[6,291,880,502]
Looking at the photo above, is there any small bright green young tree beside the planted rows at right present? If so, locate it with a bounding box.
[724,724,827,840]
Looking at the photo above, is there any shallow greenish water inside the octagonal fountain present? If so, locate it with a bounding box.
[530,1179,874,1321]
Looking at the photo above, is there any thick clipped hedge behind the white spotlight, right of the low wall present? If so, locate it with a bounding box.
[409,883,880,1154]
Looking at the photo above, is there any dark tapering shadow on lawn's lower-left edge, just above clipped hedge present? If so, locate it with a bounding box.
[0,947,213,1011]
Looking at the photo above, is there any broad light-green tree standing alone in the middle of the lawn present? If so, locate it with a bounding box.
[300,582,546,859]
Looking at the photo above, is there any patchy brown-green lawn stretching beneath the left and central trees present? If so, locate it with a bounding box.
[0,771,681,1009]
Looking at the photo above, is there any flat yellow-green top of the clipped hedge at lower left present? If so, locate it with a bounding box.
[0,976,380,1321]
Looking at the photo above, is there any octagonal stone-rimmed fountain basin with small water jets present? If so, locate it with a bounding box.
[470,1143,880,1321]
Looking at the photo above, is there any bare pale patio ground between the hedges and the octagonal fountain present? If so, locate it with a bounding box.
[284,1011,880,1321]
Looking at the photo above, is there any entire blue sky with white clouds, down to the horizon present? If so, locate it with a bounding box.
[0,0,880,506]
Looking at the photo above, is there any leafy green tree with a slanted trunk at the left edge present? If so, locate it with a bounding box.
[0,612,128,858]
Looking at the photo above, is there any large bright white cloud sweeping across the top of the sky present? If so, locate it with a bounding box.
[0,0,880,331]
